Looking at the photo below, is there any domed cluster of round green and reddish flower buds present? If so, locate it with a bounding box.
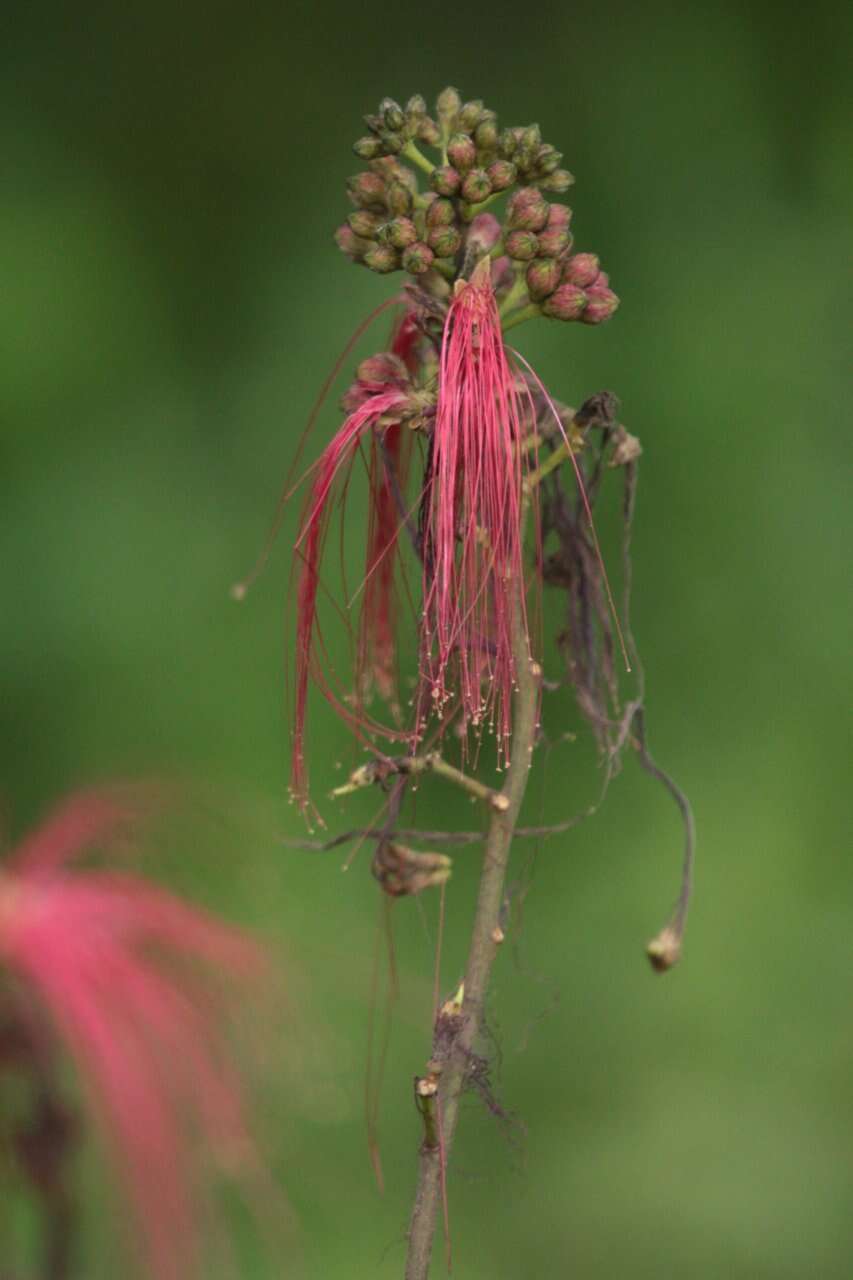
[336,88,619,324]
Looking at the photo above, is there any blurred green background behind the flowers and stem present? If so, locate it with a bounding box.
[0,0,853,1280]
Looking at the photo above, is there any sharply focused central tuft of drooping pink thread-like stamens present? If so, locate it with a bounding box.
[421,259,525,754]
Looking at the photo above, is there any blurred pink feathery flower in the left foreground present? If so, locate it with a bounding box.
[0,794,263,1280]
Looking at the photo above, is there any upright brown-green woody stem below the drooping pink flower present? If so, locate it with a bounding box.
[406,504,540,1280]
